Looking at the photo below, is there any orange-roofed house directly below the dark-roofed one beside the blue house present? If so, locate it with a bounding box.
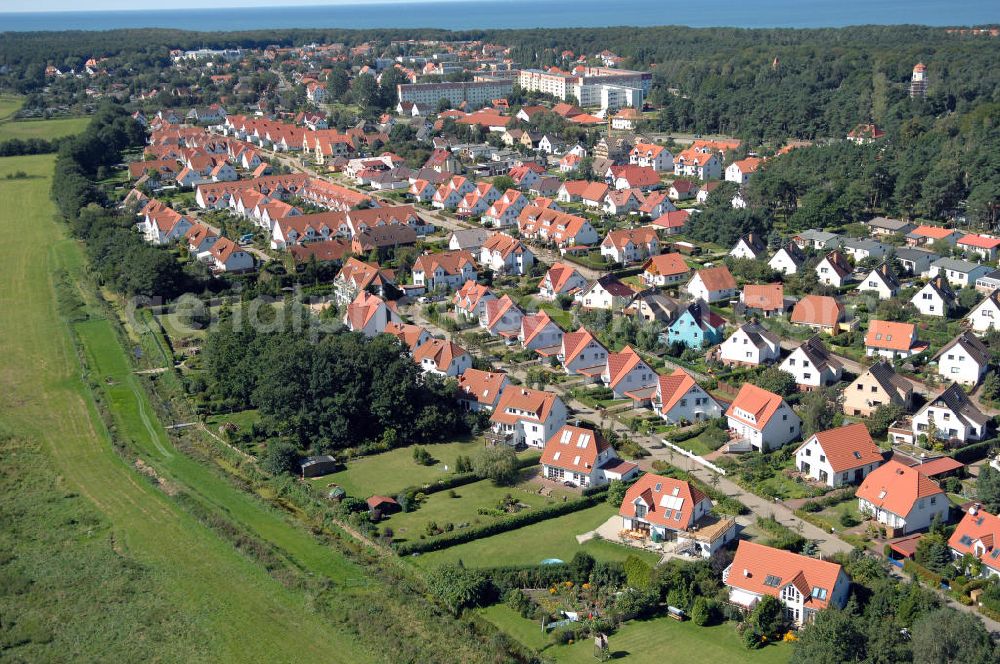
[726,383,802,452]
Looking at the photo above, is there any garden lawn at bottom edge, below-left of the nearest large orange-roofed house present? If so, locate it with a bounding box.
[544,617,792,664]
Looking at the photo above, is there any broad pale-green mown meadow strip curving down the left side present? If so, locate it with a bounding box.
[0,156,368,662]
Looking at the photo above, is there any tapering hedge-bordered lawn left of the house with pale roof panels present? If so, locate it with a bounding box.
[411,504,659,567]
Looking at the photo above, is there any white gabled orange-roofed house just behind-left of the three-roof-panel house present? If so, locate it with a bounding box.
[487,386,566,449]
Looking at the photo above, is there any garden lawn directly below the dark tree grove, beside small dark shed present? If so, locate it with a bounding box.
[312,440,483,498]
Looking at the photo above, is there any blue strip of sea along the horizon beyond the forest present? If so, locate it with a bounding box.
[0,0,1000,32]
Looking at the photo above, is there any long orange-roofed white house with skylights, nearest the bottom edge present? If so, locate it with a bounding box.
[722,540,851,626]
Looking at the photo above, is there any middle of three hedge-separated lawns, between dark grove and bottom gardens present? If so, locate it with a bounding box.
[385,478,556,540]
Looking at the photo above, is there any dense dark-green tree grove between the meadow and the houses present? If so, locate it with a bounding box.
[204,303,470,451]
